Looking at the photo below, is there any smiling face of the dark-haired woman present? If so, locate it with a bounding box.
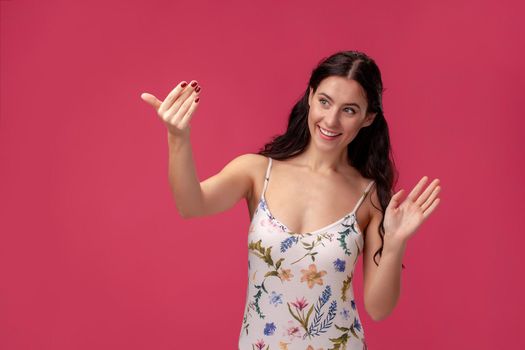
[308,76,375,151]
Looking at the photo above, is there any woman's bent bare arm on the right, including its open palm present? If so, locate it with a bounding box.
[363,176,441,321]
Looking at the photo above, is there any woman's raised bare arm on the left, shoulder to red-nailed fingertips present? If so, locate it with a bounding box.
[141,80,252,218]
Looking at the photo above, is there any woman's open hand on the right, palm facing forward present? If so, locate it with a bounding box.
[383,176,441,243]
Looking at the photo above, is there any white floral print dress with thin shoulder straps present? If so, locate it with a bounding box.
[239,158,374,350]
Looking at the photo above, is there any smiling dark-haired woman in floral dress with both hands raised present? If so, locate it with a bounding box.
[142,51,440,350]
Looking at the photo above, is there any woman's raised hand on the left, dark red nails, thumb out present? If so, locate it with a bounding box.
[140,80,201,137]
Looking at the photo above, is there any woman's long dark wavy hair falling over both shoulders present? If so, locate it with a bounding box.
[258,51,404,268]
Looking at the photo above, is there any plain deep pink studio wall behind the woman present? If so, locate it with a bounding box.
[0,0,525,350]
